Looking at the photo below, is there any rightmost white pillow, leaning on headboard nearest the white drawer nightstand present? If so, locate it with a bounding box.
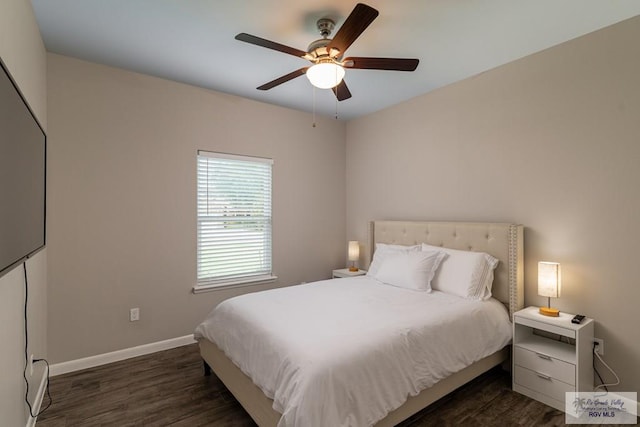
[422,243,499,300]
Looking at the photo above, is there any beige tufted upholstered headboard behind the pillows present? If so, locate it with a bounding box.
[366,221,524,316]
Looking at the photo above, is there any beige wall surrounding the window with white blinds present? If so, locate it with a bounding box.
[48,54,346,362]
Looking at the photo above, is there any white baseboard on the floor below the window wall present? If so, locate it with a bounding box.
[51,335,197,377]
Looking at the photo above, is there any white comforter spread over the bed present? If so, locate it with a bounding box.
[195,276,511,427]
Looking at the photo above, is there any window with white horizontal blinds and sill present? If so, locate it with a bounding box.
[194,151,276,291]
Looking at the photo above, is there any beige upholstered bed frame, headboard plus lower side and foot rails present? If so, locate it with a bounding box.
[199,221,524,427]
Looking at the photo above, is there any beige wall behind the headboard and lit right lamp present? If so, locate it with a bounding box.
[347,17,640,391]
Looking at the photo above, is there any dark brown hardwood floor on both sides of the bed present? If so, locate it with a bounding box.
[37,344,564,427]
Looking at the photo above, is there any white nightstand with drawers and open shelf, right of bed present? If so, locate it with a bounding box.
[512,307,594,412]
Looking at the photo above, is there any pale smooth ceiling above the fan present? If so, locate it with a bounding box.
[32,0,640,120]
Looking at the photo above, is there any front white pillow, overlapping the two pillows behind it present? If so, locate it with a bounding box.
[374,251,445,292]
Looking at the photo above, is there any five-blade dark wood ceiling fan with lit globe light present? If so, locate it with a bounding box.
[236,3,419,101]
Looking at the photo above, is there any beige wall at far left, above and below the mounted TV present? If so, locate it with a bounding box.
[0,0,47,426]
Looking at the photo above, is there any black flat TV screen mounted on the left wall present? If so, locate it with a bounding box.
[0,60,47,277]
